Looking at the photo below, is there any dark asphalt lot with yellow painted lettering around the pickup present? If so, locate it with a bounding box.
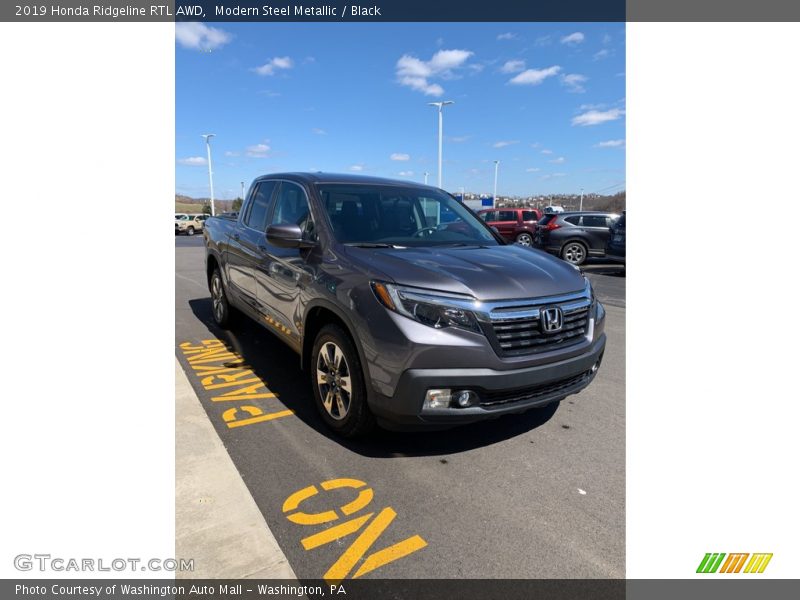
[175,236,625,578]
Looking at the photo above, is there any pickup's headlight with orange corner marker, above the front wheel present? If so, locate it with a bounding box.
[370,281,481,333]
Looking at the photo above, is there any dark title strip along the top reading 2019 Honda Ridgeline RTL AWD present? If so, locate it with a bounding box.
[0,0,800,23]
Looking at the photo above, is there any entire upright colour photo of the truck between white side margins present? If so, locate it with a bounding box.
[175,22,626,583]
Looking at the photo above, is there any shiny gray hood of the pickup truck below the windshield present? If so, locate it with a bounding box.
[345,244,585,301]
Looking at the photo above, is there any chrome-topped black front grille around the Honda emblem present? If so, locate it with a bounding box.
[484,298,591,356]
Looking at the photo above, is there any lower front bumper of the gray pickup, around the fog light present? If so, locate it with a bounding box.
[370,334,606,428]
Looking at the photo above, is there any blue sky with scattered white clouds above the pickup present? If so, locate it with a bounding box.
[175,23,625,198]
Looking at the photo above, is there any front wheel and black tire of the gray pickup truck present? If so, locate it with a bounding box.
[310,324,375,438]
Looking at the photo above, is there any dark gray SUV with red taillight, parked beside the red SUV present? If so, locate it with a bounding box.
[535,211,619,266]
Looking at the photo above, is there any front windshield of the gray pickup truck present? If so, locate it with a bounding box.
[318,184,498,246]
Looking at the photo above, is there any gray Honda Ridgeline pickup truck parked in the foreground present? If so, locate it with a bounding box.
[204,173,606,436]
